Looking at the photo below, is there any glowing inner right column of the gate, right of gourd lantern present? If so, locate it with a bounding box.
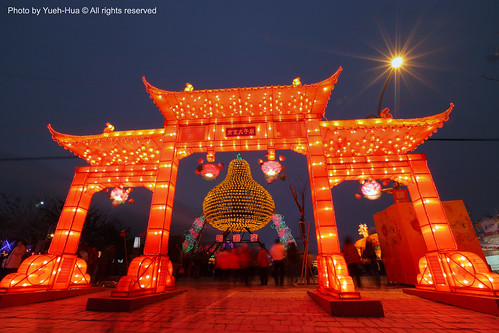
[306,120,360,298]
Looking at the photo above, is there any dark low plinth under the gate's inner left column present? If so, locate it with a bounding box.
[86,290,186,312]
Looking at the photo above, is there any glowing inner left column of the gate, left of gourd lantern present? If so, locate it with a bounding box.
[112,126,179,297]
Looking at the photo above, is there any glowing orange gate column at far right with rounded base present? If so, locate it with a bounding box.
[407,154,499,296]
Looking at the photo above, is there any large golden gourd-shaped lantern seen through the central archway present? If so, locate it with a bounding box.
[203,158,275,232]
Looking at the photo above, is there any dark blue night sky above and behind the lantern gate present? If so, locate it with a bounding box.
[0,0,499,253]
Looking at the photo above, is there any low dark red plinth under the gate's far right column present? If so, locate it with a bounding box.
[403,288,499,316]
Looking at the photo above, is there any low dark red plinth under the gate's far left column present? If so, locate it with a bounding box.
[0,287,105,309]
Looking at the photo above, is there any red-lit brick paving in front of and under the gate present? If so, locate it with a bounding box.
[0,281,499,333]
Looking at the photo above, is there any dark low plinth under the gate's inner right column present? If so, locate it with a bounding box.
[308,291,385,318]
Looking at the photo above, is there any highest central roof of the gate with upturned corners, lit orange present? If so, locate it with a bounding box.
[143,67,342,124]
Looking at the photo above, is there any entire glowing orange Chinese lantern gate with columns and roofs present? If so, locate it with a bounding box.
[0,68,499,298]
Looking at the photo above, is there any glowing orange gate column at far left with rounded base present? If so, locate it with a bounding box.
[0,168,93,292]
